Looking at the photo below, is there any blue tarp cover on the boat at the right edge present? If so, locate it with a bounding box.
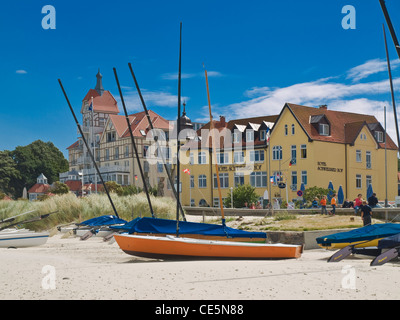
[316,223,400,244]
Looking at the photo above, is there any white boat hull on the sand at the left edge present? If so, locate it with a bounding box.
[0,229,49,248]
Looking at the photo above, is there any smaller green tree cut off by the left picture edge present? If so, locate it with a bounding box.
[0,150,21,195]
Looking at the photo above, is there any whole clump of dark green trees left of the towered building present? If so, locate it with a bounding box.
[0,140,69,199]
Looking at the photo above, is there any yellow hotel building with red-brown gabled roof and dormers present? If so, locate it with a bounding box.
[180,103,398,206]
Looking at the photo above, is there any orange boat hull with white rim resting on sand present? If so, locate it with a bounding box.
[114,234,302,259]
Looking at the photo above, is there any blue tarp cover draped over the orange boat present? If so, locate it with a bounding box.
[112,217,267,239]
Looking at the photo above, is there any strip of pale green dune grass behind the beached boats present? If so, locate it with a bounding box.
[0,193,176,230]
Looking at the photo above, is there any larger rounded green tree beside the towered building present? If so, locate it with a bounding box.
[10,140,69,197]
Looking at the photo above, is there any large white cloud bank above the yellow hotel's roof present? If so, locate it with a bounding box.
[191,59,400,143]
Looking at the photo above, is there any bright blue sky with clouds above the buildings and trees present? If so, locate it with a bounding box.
[0,0,400,154]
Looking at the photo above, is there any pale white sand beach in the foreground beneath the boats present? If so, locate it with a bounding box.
[0,235,400,300]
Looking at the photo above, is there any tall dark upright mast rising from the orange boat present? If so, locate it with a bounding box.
[176,22,182,237]
